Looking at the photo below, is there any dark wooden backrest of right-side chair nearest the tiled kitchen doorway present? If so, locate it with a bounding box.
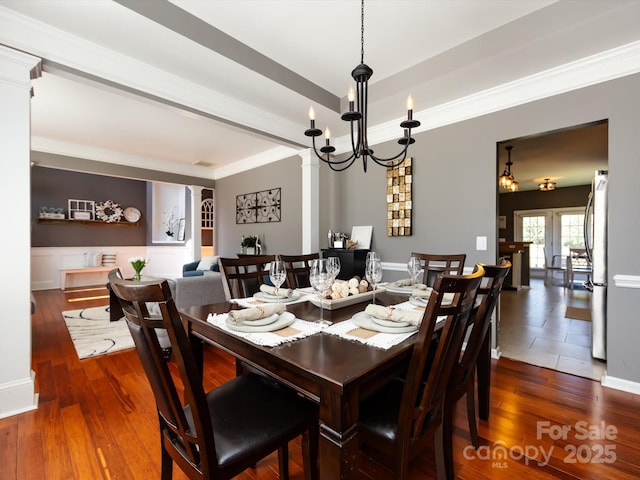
[449,260,511,388]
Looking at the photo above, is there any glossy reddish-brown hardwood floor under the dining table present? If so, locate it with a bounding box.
[0,289,640,480]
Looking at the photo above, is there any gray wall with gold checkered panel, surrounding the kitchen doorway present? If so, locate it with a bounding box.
[320,75,640,382]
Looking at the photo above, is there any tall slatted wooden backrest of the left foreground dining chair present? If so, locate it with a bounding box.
[109,269,217,478]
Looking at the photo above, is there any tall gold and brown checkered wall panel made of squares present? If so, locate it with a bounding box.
[387,158,413,237]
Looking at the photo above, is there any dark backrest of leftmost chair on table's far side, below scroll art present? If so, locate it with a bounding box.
[218,255,275,300]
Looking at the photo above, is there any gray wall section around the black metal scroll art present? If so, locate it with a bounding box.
[215,155,302,257]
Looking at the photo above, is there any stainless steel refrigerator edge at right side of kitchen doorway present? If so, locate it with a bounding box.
[584,170,609,360]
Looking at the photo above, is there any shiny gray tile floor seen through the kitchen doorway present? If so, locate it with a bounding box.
[498,278,606,381]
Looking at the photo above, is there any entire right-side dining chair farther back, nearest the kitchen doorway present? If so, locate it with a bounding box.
[443,260,511,479]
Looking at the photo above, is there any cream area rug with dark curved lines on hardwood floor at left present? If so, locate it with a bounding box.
[62,306,134,359]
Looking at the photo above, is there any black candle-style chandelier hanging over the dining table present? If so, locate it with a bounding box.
[304,0,420,172]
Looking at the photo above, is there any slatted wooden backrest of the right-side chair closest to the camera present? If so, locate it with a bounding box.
[395,265,484,450]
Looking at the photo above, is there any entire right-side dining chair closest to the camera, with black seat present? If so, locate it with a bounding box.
[357,265,484,480]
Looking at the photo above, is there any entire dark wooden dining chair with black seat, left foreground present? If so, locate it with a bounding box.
[109,269,319,480]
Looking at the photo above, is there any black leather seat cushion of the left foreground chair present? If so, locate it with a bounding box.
[185,373,317,467]
